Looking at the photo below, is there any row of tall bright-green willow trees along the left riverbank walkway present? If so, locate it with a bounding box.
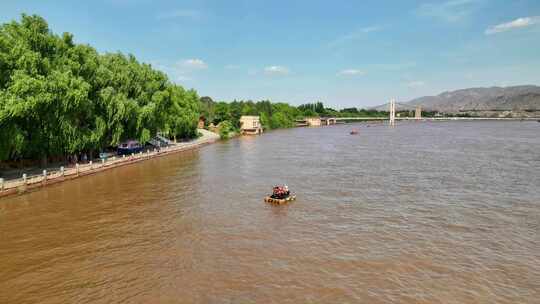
[0,15,199,164]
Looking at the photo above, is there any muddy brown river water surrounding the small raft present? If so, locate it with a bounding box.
[0,121,540,304]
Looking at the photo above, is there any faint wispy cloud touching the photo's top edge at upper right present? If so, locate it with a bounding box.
[416,0,480,22]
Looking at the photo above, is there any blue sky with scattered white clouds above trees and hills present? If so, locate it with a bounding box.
[0,0,540,108]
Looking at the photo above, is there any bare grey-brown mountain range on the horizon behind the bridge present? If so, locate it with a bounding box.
[373,85,540,113]
